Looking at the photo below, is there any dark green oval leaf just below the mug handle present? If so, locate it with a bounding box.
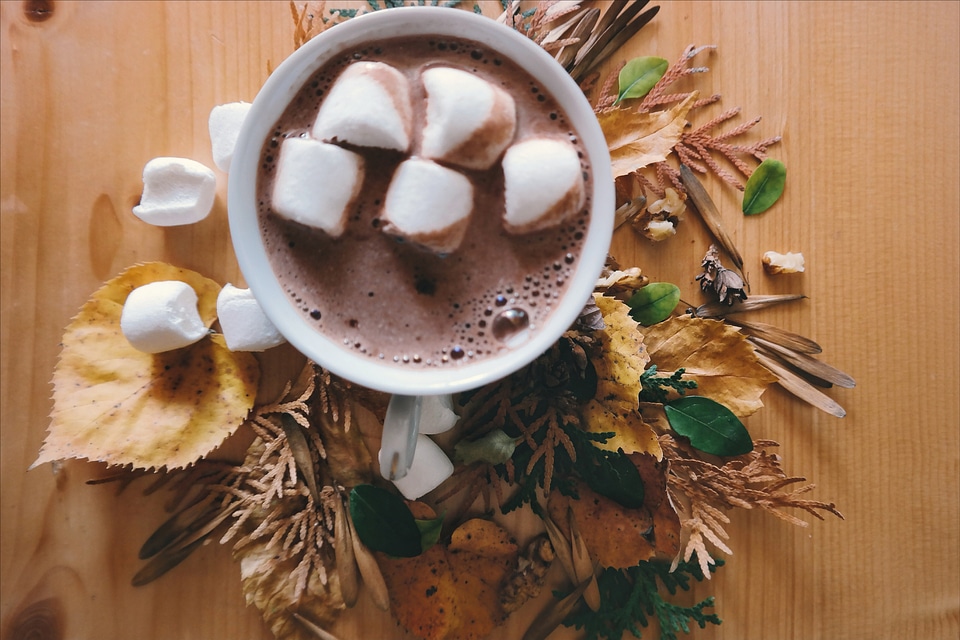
[350,484,423,558]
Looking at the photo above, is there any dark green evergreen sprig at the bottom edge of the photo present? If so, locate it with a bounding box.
[561,559,723,640]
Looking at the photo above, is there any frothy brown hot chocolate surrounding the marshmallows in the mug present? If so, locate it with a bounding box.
[257,37,593,368]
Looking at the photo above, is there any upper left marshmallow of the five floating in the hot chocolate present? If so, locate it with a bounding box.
[313,62,413,152]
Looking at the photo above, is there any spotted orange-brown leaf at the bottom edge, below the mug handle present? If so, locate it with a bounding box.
[377,518,519,640]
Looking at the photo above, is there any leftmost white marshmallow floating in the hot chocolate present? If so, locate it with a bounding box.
[272,138,363,237]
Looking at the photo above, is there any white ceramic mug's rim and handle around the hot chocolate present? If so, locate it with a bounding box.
[228,7,615,478]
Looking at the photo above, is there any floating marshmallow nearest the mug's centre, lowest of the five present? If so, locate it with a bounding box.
[382,158,473,253]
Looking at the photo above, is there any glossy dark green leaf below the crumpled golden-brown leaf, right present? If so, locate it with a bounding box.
[664,396,753,456]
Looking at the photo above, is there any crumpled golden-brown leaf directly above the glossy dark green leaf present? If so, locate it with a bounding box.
[644,316,777,418]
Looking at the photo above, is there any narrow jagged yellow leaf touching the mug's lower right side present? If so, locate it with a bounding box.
[583,294,663,459]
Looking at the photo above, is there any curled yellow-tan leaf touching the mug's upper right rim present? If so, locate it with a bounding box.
[597,91,697,178]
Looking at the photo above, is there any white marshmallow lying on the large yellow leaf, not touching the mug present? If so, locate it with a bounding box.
[120,280,207,353]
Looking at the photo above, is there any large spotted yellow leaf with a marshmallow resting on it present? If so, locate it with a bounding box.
[33,262,260,469]
